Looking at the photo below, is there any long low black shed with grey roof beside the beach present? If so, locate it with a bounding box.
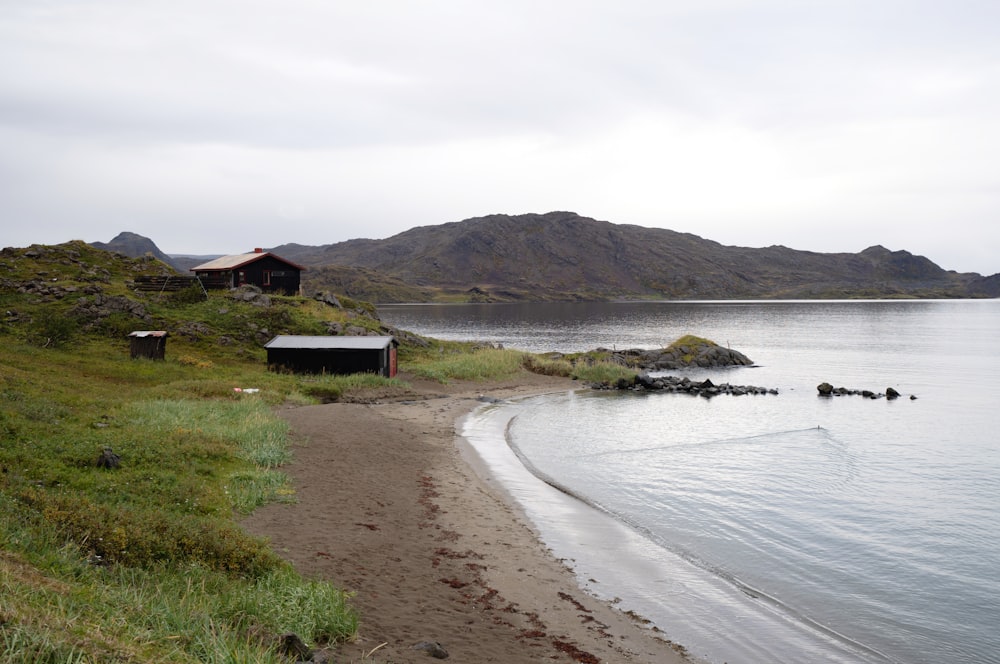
[264,335,399,378]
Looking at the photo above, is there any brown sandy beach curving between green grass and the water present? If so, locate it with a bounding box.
[244,375,690,664]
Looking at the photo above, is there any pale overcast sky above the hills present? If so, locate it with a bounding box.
[0,0,1000,275]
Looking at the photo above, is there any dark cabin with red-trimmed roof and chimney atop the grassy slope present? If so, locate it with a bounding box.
[191,249,305,295]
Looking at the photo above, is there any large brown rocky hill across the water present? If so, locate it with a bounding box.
[270,212,1000,302]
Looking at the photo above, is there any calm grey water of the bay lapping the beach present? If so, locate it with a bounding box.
[380,300,1000,664]
